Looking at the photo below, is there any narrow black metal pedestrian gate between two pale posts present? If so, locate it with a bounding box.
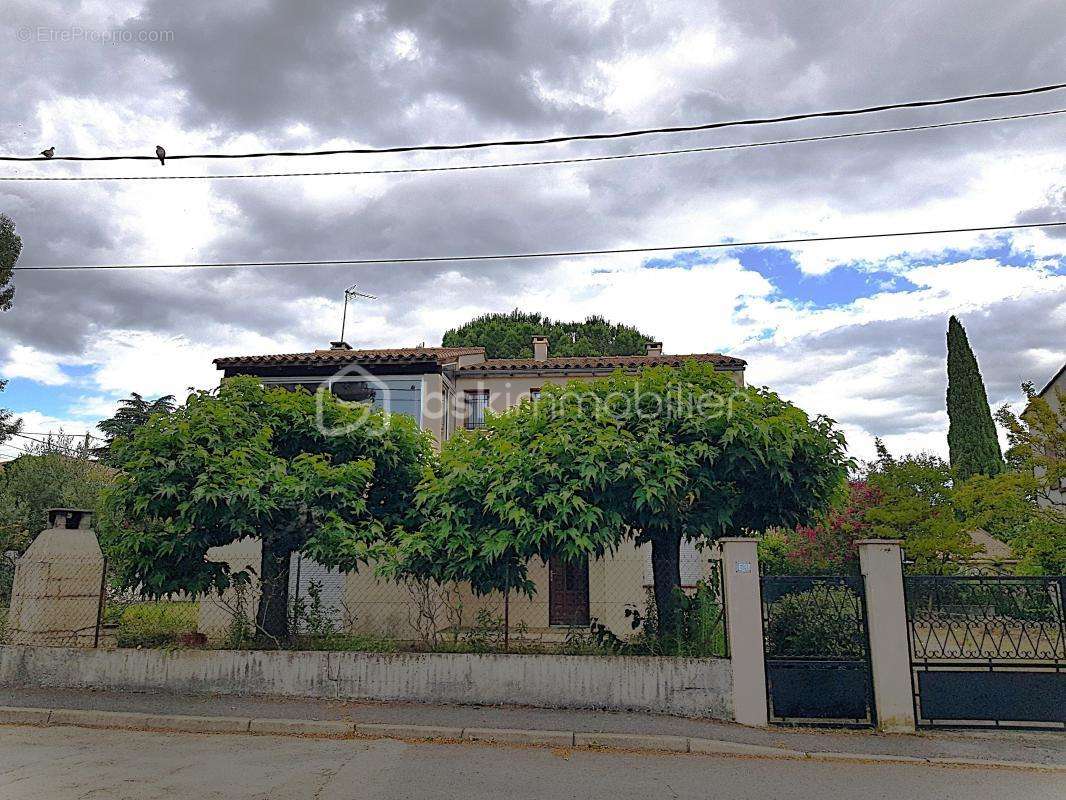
[761,575,876,726]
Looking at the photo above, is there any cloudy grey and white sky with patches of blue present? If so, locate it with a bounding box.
[0,0,1066,459]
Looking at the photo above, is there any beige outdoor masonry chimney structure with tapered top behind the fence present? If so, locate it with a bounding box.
[7,509,103,647]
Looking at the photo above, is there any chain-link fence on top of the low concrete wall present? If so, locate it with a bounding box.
[0,540,726,657]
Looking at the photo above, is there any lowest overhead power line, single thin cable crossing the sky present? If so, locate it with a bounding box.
[12,221,1066,272]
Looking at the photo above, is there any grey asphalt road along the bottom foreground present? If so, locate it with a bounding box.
[0,727,1066,800]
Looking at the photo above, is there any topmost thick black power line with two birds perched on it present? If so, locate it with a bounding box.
[8,83,1066,161]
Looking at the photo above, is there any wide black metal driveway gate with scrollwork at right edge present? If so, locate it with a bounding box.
[904,575,1066,730]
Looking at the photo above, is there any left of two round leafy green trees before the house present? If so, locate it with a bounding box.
[104,378,433,640]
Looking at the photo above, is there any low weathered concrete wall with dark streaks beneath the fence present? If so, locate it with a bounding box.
[0,646,732,719]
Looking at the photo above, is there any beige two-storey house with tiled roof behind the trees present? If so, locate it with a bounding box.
[200,337,745,638]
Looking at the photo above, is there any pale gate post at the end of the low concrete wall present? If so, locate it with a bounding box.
[718,538,768,727]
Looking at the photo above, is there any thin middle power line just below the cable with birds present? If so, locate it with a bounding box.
[0,109,1066,181]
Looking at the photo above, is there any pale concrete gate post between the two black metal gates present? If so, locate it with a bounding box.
[856,539,915,733]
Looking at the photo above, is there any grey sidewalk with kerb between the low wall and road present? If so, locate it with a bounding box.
[0,688,1066,767]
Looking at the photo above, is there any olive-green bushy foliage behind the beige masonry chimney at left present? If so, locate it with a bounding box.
[0,434,114,553]
